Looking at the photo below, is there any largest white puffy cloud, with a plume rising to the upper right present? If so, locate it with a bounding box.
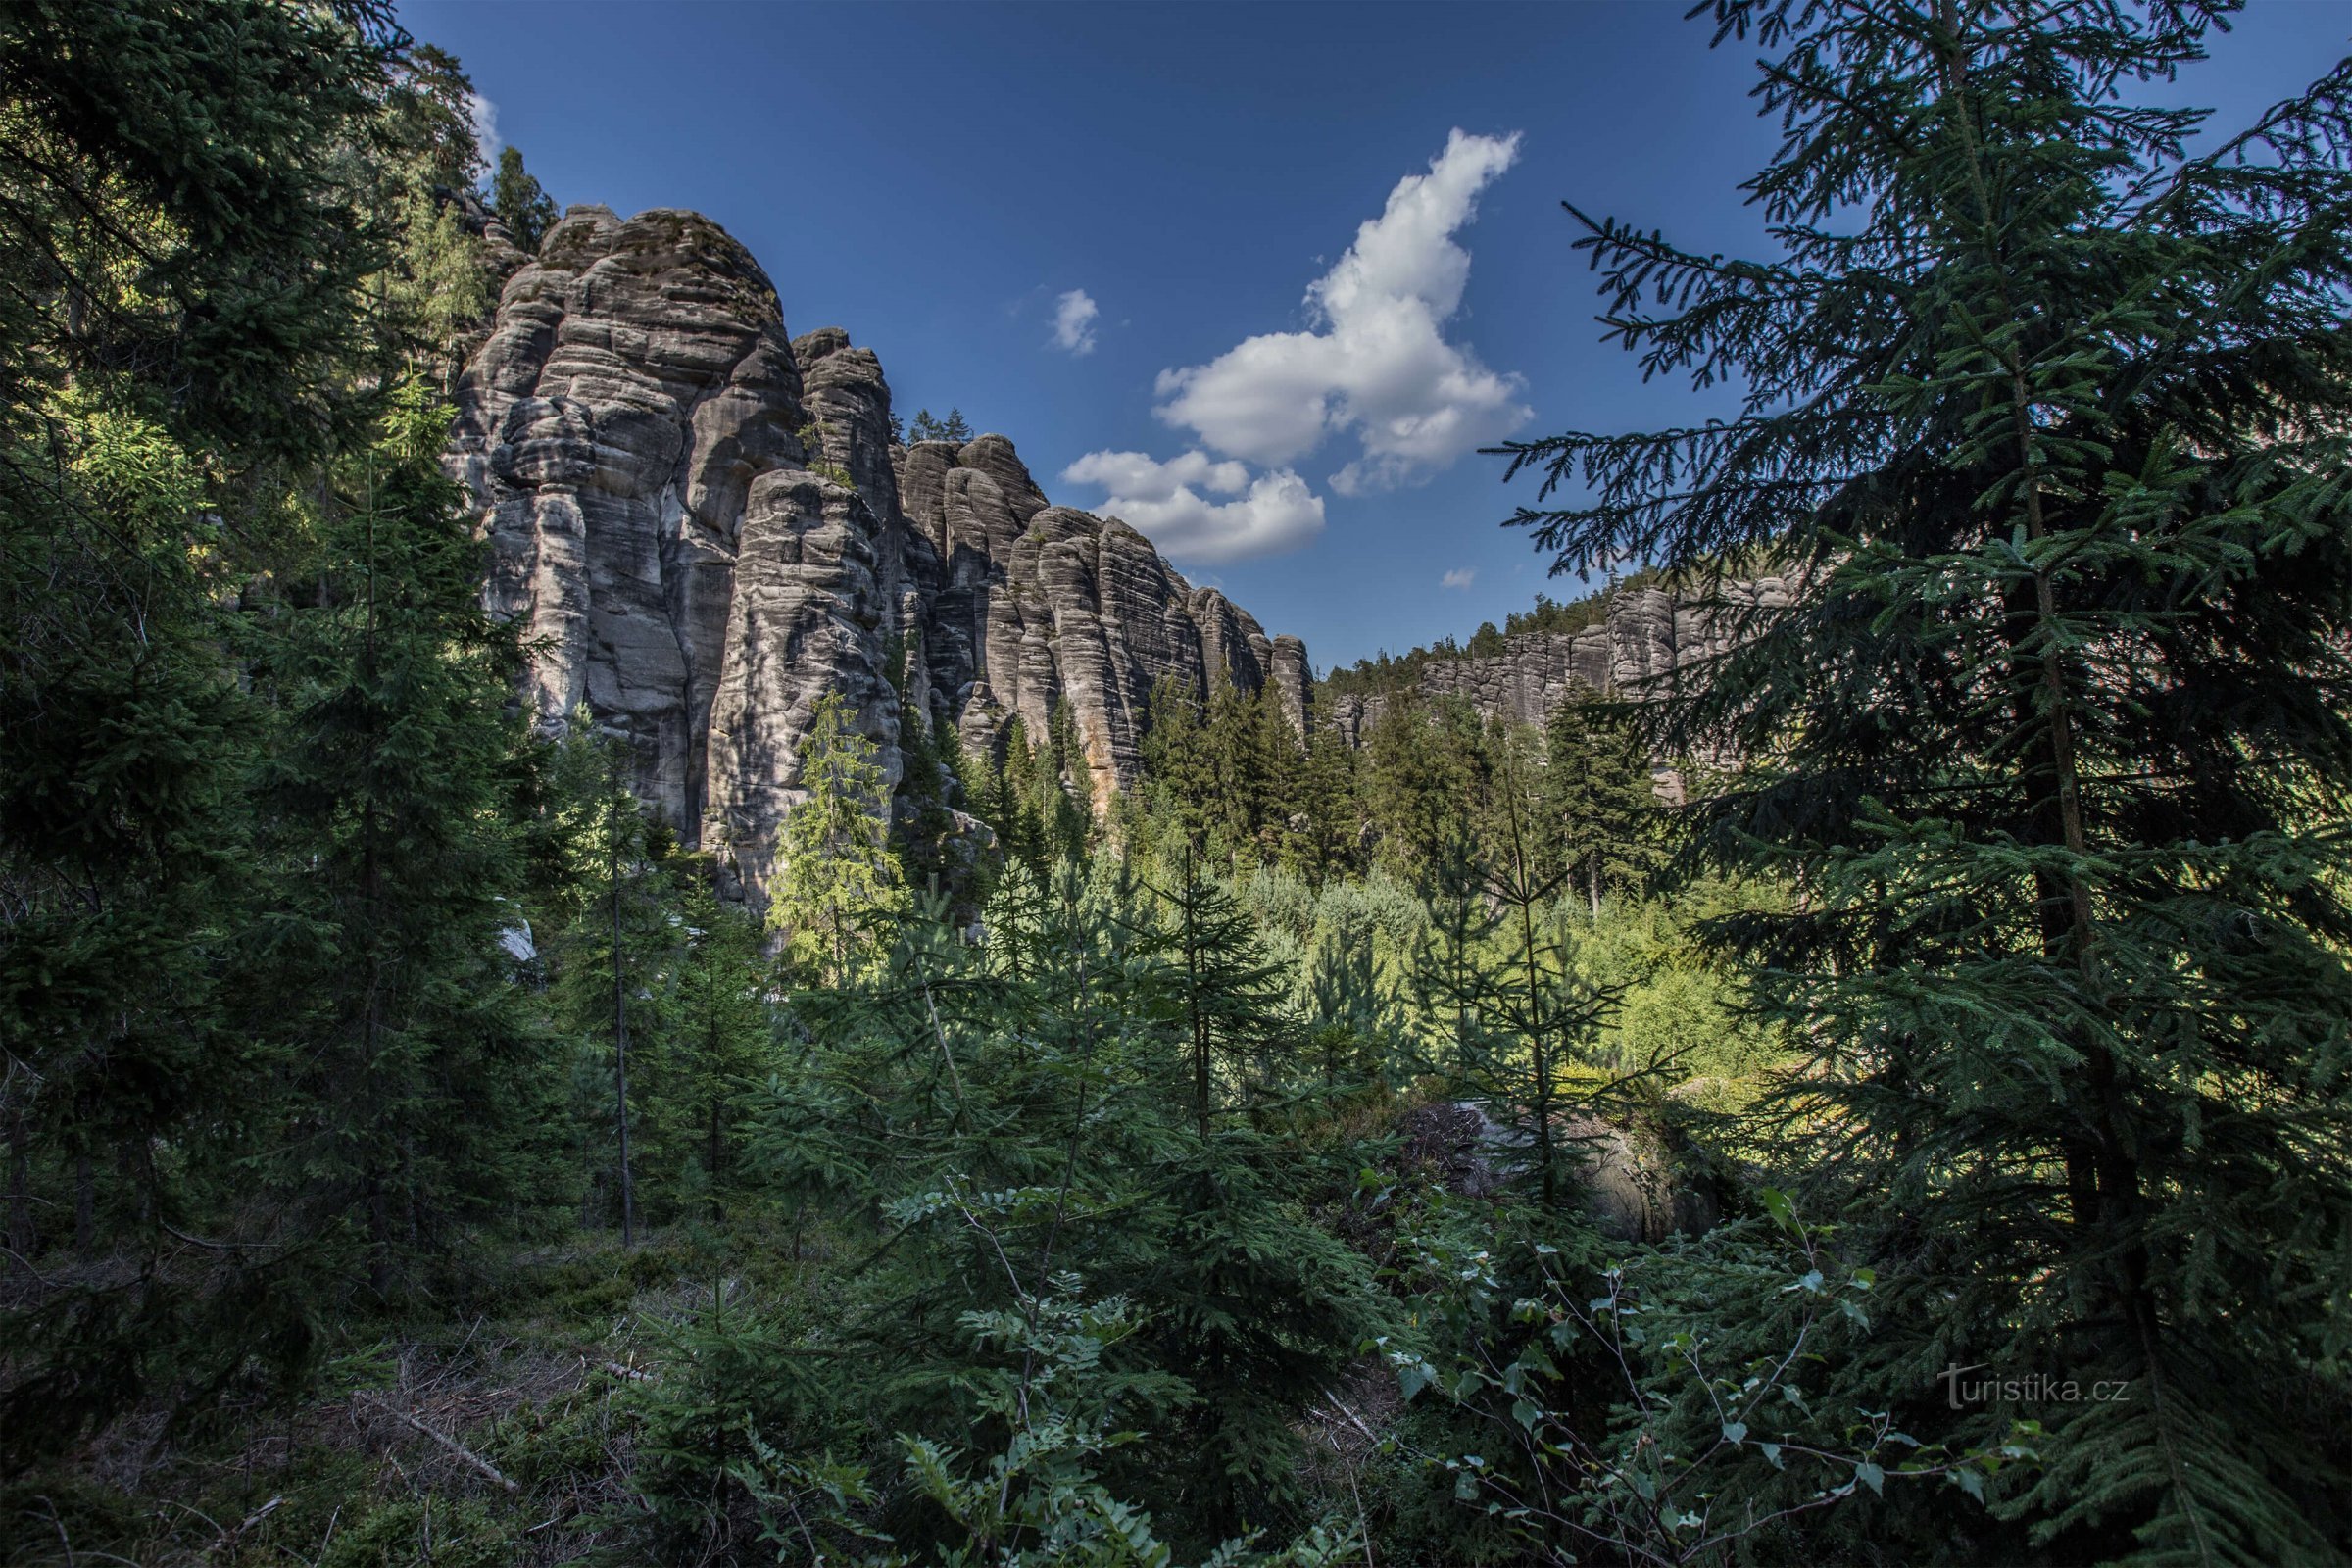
[1154,129,1531,496]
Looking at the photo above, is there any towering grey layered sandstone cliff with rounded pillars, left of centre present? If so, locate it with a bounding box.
[449,207,1307,894]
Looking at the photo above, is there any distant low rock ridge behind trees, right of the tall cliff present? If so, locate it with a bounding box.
[1317,576,1792,745]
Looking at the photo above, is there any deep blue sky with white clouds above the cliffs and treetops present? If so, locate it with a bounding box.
[400,0,2352,667]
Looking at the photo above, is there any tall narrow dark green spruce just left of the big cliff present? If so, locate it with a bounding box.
[249,388,568,1296]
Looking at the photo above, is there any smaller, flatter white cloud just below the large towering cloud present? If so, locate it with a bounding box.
[1060,452,1322,564]
